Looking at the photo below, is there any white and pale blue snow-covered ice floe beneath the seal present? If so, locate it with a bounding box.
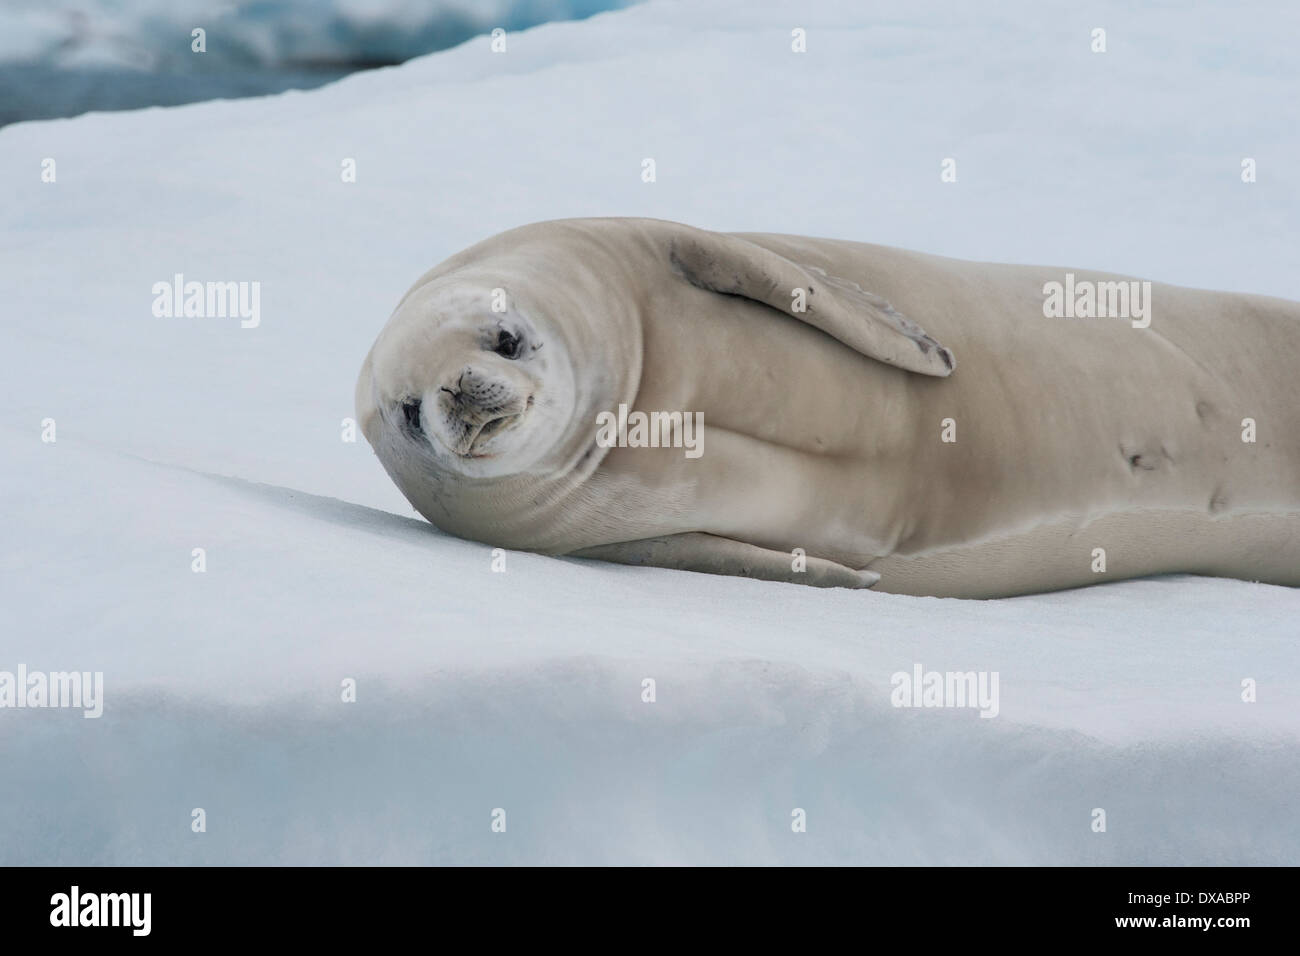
[0,0,1300,865]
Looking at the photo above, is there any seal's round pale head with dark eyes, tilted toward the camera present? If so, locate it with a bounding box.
[356,222,641,550]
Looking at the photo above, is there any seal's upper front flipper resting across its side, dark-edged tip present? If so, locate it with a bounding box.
[668,225,956,378]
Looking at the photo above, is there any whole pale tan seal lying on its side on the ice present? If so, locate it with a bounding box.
[358,219,1300,597]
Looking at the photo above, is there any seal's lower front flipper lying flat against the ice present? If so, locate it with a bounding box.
[566,531,880,588]
